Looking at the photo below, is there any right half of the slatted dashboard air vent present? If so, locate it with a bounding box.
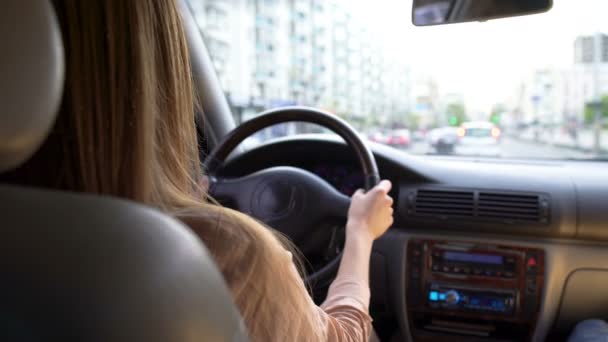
[477,192,549,223]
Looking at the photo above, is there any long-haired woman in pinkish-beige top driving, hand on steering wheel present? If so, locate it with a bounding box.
[3,0,393,341]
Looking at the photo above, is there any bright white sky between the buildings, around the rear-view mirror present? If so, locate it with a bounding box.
[344,0,608,111]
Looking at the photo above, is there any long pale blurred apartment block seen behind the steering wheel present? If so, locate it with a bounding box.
[188,0,410,122]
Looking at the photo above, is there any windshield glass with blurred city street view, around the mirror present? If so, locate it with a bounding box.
[188,0,608,159]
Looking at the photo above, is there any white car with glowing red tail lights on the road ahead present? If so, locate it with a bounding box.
[455,121,501,157]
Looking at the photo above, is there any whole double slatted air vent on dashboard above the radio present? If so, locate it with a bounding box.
[407,188,550,224]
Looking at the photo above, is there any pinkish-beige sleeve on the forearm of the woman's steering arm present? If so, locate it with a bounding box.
[289,253,372,342]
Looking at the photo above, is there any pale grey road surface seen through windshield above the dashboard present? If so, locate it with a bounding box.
[407,137,594,159]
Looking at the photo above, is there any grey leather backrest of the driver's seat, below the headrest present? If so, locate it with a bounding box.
[0,186,247,342]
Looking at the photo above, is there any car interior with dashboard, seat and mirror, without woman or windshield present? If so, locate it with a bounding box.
[0,0,608,341]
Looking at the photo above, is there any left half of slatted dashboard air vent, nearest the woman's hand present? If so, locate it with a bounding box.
[413,190,475,217]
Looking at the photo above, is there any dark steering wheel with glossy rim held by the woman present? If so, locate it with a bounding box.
[205,106,380,284]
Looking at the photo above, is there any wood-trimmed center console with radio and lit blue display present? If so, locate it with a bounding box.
[406,240,545,341]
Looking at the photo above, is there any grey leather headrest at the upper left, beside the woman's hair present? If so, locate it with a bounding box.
[0,0,64,172]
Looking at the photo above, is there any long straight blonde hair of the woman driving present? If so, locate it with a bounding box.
[3,0,314,338]
